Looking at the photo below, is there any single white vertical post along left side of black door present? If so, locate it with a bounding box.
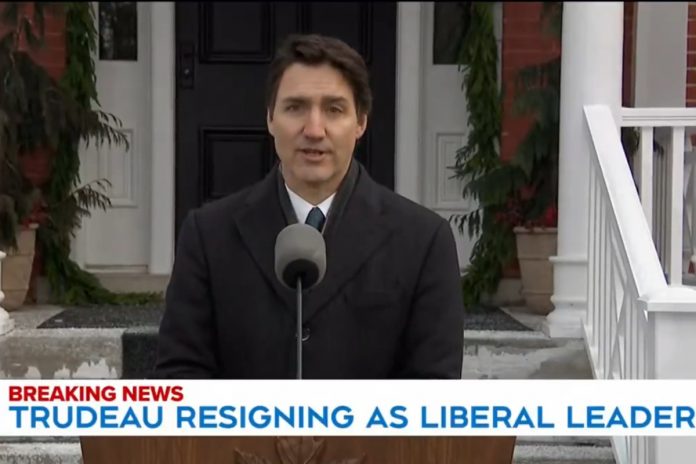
[149,2,176,274]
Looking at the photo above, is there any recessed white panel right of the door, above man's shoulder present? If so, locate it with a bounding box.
[434,132,471,210]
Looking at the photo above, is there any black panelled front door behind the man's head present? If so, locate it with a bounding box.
[176,2,396,236]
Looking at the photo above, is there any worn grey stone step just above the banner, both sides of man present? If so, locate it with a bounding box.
[0,306,592,379]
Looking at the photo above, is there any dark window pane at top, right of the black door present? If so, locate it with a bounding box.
[433,2,469,64]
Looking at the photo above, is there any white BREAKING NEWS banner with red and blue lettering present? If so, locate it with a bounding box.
[0,380,696,436]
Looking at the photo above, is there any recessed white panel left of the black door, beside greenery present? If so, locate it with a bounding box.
[97,129,138,208]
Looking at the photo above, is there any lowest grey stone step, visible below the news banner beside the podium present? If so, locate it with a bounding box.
[0,437,615,464]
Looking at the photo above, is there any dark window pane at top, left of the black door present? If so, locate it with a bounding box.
[99,2,138,61]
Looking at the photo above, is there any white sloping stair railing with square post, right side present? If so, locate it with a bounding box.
[583,105,696,464]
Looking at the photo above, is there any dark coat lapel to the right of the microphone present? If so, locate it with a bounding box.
[303,167,395,321]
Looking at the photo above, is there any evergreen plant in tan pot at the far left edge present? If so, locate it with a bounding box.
[0,6,54,310]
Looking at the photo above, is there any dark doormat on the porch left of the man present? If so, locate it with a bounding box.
[38,304,164,329]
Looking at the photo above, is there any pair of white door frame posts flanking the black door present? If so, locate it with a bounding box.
[149,2,423,274]
